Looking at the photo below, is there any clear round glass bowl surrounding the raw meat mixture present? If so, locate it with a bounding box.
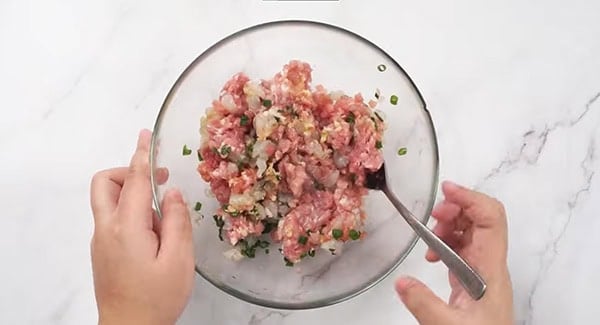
[150,21,438,309]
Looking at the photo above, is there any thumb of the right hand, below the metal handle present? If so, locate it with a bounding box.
[396,277,453,325]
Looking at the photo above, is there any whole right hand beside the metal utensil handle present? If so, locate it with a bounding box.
[396,182,513,325]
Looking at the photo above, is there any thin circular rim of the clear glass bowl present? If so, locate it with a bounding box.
[149,19,439,310]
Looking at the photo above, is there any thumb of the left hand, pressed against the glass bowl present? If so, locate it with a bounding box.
[158,190,193,261]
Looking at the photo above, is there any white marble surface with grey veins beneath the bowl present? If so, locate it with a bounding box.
[0,0,600,325]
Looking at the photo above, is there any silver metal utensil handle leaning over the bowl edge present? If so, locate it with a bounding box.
[383,186,487,300]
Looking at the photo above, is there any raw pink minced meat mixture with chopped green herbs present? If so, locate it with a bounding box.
[198,61,385,266]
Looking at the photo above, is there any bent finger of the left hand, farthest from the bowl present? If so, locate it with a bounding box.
[90,167,127,223]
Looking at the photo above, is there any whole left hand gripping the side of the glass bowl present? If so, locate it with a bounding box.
[91,130,194,325]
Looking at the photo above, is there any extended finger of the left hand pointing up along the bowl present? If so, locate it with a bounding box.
[119,130,152,229]
